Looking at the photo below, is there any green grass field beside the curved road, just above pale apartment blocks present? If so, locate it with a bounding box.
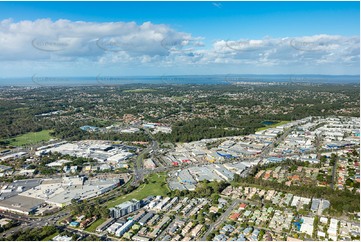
[107,173,170,208]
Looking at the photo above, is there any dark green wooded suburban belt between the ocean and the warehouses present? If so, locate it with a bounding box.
[0,84,360,145]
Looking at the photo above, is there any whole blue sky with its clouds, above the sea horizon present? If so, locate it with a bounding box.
[0,2,360,77]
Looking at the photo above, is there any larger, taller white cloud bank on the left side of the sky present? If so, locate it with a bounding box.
[0,19,197,60]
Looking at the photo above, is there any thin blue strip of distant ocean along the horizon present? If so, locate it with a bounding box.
[0,75,360,87]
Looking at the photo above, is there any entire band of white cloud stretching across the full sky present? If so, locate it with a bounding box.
[0,19,360,74]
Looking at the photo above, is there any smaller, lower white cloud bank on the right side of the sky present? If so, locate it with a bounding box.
[213,35,360,65]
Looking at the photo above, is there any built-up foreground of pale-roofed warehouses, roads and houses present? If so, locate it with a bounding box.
[0,95,360,241]
